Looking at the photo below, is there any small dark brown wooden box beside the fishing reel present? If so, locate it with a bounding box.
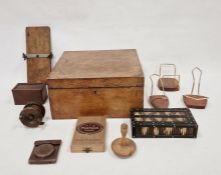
[12,83,47,105]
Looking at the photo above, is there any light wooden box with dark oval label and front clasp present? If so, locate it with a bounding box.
[71,117,106,153]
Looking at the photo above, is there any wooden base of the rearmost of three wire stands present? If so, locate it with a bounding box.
[158,78,180,91]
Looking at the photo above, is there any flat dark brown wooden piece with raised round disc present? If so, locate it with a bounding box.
[28,140,61,164]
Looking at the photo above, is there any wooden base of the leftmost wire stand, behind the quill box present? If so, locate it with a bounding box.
[149,95,169,108]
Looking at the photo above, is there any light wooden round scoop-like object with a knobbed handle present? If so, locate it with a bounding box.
[111,123,136,158]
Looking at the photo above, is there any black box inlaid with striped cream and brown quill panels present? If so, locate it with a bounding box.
[131,108,198,138]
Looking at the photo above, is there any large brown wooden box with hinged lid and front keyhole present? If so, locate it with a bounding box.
[47,49,144,119]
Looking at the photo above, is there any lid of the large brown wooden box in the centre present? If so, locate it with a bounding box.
[47,49,144,88]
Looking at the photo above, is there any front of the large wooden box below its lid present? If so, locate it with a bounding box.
[49,87,143,119]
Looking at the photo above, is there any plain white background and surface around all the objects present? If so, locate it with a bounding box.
[0,0,221,175]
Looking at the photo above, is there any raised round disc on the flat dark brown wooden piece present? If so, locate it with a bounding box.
[34,144,55,158]
